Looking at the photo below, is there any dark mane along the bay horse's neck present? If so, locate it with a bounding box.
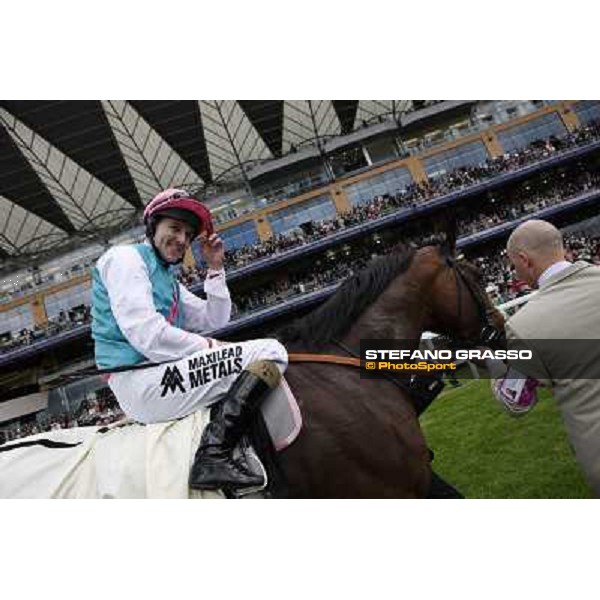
[274,246,415,348]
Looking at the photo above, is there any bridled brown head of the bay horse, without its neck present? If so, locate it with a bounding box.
[424,246,504,344]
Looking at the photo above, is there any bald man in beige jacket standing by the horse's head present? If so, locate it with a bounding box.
[506,220,600,496]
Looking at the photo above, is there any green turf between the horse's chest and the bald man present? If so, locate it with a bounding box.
[421,380,593,498]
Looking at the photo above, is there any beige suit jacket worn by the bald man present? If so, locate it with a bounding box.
[506,262,600,496]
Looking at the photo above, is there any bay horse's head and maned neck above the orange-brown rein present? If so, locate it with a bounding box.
[277,240,504,349]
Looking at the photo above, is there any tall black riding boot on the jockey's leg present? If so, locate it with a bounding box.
[189,361,280,490]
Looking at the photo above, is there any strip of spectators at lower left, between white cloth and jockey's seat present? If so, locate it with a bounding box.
[0,388,125,444]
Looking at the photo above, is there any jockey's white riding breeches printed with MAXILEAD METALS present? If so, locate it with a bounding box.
[108,338,288,423]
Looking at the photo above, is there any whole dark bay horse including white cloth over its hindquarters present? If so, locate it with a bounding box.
[0,245,504,498]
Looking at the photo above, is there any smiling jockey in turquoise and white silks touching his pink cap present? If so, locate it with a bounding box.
[92,189,287,490]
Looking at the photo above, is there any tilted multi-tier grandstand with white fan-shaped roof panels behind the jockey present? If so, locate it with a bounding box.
[0,100,600,443]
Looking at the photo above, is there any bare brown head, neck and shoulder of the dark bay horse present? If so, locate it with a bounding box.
[278,241,504,498]
